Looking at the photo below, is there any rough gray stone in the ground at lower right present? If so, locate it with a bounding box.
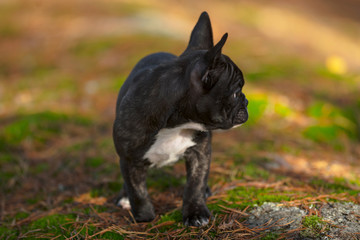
[245,203,360,239]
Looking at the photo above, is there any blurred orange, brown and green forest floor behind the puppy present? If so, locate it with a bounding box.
[0,0,360,237]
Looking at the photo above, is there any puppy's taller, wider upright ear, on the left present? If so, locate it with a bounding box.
[184,12,214,53]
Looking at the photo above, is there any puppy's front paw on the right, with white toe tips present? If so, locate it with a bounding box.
[183,206,211,227]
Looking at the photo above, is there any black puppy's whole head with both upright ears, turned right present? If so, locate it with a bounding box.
[180,12,248,129]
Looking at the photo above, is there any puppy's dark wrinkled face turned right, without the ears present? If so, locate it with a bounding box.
[196,55,248,129]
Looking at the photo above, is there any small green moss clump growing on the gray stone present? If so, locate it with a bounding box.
[301,215,329,238]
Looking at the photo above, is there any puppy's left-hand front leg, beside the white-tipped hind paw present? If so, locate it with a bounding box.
[120,158,155,222]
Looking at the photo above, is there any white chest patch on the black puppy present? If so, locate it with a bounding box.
[144,123,206,167]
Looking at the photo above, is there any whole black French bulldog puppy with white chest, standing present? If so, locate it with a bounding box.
[113,12,248,226]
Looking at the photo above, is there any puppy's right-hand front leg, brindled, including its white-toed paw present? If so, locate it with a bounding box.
[183,132,211,227]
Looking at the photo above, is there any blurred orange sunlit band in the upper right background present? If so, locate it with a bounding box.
[250,4,360,71]
